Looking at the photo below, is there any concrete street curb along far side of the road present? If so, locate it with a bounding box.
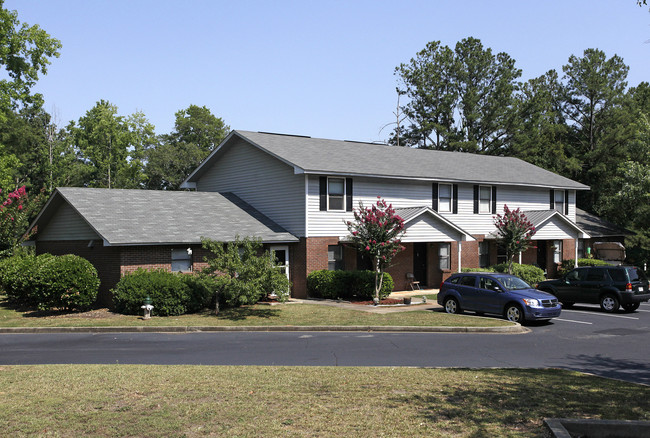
[0,324,530,334]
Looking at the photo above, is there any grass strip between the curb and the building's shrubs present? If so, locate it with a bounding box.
[0,304,511,327]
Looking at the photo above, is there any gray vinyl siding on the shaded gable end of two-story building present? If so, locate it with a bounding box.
[196,140,305,236]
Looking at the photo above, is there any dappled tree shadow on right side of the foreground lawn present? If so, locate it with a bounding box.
[393,369,650,437]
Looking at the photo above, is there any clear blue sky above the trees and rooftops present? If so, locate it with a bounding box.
[5,0,650,141]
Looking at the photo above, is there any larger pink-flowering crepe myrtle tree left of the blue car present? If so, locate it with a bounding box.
[345,196,404,303]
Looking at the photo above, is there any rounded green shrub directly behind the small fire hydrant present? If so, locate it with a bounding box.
[113,269,192,316]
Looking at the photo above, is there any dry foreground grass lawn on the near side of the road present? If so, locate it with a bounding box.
[0,365,650,437]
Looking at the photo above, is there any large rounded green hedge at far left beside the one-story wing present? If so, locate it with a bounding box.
[0,254,99,310]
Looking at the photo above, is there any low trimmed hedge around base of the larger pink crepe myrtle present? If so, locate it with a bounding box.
[307,269,394,300]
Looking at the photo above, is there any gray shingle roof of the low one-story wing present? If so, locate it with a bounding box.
[36,188,298,245]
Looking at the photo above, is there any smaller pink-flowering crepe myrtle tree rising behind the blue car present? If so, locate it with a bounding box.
[494,205,536,275]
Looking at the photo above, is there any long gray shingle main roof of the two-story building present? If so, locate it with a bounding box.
[187,131,589,190]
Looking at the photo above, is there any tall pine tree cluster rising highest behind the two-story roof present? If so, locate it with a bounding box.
[392,37,521,154]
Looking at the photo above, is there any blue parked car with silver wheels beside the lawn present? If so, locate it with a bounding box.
[438,272,562,323]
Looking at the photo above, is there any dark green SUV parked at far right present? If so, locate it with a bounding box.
[537,266,650,312]
